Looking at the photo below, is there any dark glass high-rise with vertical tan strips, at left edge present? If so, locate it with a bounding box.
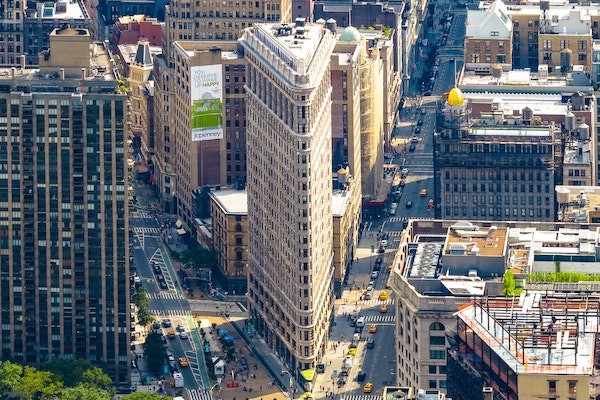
[0,28,130,383]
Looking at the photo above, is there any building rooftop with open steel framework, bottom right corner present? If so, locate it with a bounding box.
[457,291,600,375]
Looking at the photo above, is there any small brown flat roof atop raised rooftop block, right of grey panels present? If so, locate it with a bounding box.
[443,221,507,256]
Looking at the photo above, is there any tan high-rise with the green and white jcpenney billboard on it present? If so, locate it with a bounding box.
[170,41,246,232]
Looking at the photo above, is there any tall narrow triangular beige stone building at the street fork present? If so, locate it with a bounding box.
[241,19,335,377]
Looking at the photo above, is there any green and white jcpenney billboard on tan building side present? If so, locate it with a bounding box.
[190,65,223,142]
